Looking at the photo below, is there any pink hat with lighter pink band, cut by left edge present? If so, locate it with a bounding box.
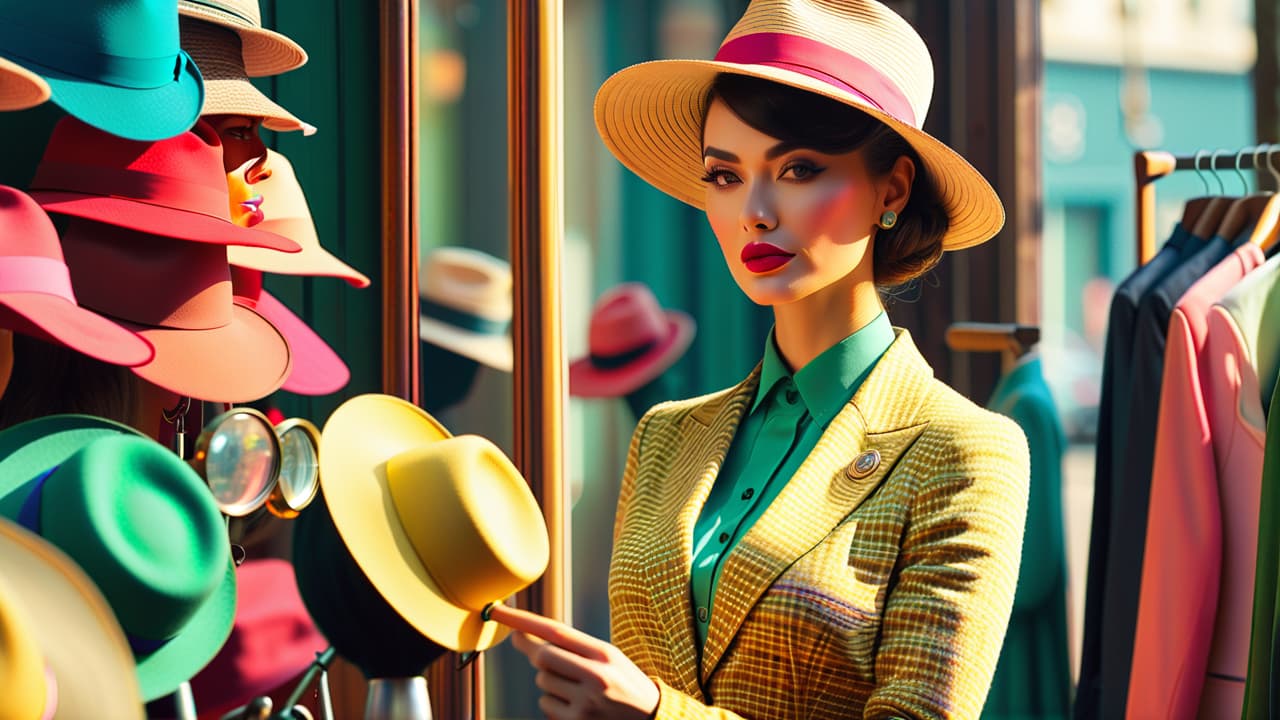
[0,186,155,365]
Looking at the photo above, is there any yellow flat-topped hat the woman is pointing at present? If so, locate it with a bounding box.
[320,395,549,652]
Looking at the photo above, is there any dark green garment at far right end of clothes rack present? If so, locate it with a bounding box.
[1244,366,1280,720]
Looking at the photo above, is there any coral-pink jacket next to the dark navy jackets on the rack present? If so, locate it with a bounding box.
[1126,243,1265,720]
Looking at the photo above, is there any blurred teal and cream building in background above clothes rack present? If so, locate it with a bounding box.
[1041,0,1256,439]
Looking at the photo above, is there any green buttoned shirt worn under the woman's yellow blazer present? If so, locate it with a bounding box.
[690,313,893,648]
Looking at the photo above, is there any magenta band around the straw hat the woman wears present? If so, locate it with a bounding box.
[716,32,919,128]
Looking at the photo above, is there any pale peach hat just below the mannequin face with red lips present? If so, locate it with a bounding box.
[227,149,369,287]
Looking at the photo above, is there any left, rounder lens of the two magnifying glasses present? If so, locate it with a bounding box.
[205,413,276,516]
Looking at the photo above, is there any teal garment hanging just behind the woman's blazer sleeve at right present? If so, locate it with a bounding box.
[982,356,1071,720]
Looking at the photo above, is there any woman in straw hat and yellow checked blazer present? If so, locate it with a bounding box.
[492,0,1029,719]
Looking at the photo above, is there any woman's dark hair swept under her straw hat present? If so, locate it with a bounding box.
[704,73,948,287]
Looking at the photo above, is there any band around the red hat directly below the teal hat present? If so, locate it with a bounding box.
[31,160,232,223]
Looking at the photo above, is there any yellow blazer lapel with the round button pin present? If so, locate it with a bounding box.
[701,331,933,684]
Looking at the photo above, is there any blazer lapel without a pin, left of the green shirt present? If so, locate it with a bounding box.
[652,366,760,697]
